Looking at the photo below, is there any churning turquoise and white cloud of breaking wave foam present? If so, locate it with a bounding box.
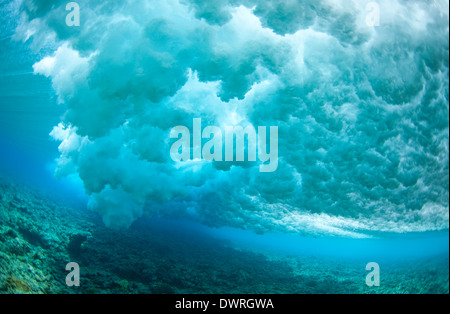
[9,0,449,237]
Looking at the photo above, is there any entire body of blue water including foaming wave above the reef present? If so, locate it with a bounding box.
[0,0,449,292]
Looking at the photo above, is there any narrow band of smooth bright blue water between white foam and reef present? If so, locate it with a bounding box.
[134,218,449,261]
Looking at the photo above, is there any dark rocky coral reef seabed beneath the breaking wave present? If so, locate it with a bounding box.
[0,177,449,294]
